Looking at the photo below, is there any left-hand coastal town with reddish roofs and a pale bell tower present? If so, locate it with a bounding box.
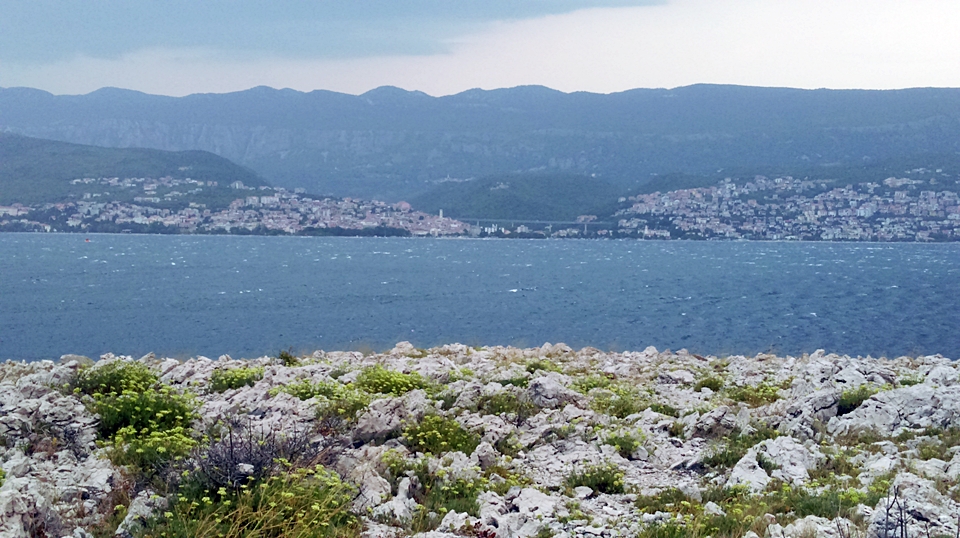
[0,177,467,237]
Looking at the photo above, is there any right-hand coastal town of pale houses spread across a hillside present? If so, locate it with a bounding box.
[617,169,960,241]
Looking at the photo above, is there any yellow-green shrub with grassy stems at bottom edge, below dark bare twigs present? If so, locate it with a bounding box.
[144,466,361,538]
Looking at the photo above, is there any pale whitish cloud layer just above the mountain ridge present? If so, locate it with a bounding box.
[0,0,960,95]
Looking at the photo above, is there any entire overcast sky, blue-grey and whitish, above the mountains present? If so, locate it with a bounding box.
[0,0,960,95]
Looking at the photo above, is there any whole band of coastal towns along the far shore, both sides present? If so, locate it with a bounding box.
[0,169,960,242]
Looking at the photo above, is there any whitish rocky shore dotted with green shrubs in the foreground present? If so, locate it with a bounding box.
[0,342,960,538]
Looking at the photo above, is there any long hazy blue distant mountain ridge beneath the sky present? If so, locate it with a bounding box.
[0,85,960,200]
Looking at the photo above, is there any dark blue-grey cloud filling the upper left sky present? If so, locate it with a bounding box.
[0,0,665,65]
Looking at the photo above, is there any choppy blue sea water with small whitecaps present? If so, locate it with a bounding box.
[0,234,960,360]
